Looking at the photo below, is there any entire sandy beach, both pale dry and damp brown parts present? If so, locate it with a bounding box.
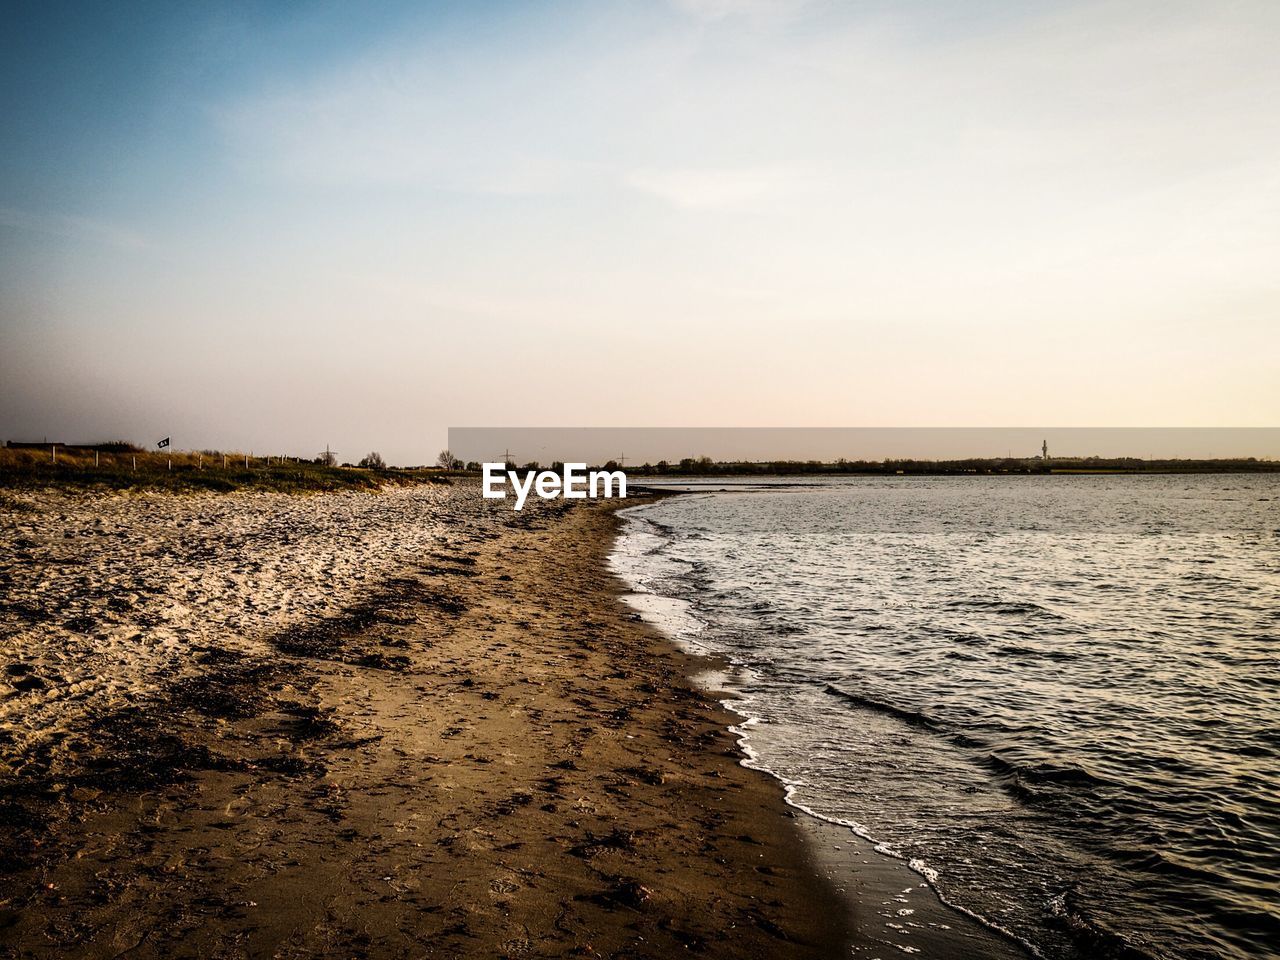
[0,488,1024,957]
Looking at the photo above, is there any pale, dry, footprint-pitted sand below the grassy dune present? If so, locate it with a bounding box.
[0,486,483,773]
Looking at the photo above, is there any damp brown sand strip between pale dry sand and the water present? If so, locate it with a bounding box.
[0,491,850,957]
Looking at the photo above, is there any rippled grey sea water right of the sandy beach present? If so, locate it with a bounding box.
[616,475,1280,957]
